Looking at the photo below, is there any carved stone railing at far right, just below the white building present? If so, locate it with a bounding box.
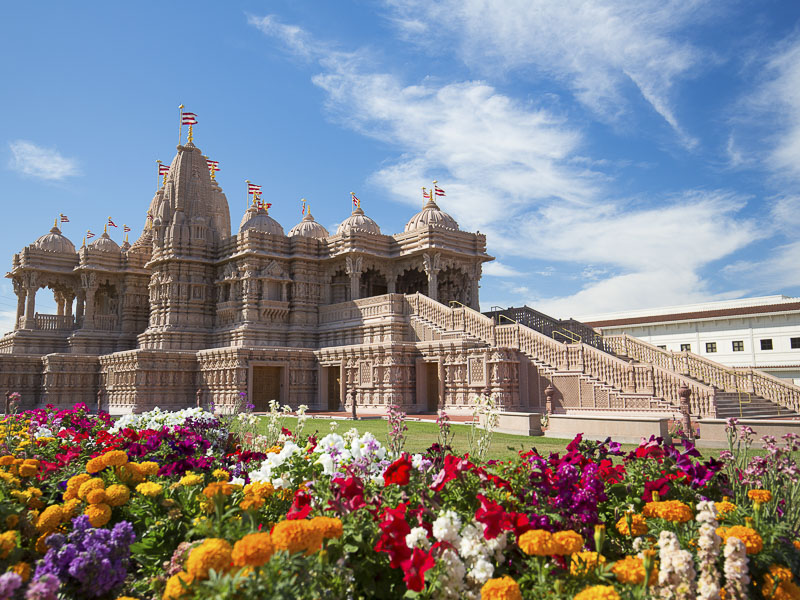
[606,334,800,412]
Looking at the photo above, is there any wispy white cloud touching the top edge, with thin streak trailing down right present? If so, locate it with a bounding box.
[387,0,712,146]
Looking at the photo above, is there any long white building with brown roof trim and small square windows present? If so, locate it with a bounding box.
[576,296,800,384]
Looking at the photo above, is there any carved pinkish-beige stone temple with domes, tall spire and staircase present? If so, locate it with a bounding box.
[0,142,800,416]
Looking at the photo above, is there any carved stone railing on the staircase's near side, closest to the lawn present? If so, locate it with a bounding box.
[406,294,716,417]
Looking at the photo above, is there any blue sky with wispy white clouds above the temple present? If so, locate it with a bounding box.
[0,0,800,330]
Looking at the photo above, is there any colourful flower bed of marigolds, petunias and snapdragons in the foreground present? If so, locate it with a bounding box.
[0,405,800,600]
